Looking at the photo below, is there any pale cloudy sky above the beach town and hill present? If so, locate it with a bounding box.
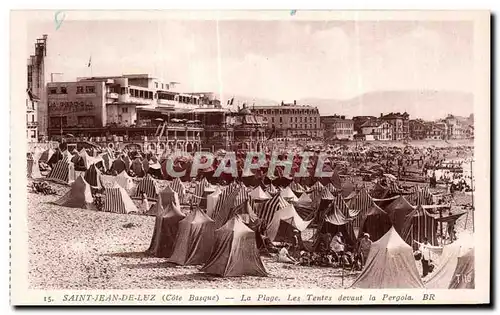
[26,20,473,101]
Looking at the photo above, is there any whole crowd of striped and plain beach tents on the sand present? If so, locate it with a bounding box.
[29,146,474,288]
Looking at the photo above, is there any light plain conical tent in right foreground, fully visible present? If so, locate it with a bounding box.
[352,228,424,290]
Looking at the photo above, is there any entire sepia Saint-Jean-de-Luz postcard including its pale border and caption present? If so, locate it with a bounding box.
[10,10,491,306]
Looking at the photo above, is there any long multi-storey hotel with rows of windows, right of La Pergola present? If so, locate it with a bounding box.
[252,102,323,138]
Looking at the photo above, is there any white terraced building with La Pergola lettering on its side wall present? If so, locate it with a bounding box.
[47,74,220,135]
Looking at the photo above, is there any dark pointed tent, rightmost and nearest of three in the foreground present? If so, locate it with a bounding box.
[201,216,267,277]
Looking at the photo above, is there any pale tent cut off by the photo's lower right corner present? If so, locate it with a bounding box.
[425,235,475,289]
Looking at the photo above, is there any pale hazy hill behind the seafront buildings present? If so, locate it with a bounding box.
[297,90,474,120]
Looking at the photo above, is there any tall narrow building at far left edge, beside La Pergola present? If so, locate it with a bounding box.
[26,35,48,141]
